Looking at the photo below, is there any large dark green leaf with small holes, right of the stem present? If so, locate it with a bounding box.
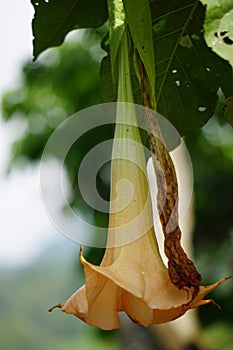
[151,0,233,135]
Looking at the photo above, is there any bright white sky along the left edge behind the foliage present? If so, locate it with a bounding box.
[0,0,67,267]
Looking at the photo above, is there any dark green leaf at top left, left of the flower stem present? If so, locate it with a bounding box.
[31,0,108,60]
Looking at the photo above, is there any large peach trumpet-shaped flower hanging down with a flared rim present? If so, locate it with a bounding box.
[49,31,229,330]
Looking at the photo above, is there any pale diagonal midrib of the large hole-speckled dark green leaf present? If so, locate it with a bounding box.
[156,1,198,102]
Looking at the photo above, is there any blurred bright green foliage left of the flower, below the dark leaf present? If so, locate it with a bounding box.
[3,30,101,161]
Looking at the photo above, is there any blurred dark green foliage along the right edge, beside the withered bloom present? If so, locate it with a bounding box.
[186,117,233,324]
